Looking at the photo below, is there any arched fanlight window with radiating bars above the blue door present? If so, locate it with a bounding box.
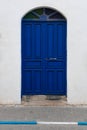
[23,8,66,21]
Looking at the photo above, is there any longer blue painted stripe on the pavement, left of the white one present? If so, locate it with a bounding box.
[0,121,37,125]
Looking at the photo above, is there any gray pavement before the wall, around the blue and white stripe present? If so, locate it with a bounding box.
[0,105,87,130]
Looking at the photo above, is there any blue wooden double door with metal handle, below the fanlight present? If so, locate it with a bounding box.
[22,21,66,95]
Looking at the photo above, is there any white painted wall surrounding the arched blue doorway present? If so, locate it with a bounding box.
[0,0,87,104]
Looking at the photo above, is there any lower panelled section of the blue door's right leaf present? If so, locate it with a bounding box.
[46,70,65,94]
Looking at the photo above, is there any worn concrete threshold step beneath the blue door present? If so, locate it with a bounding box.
[22,95,67,106]
